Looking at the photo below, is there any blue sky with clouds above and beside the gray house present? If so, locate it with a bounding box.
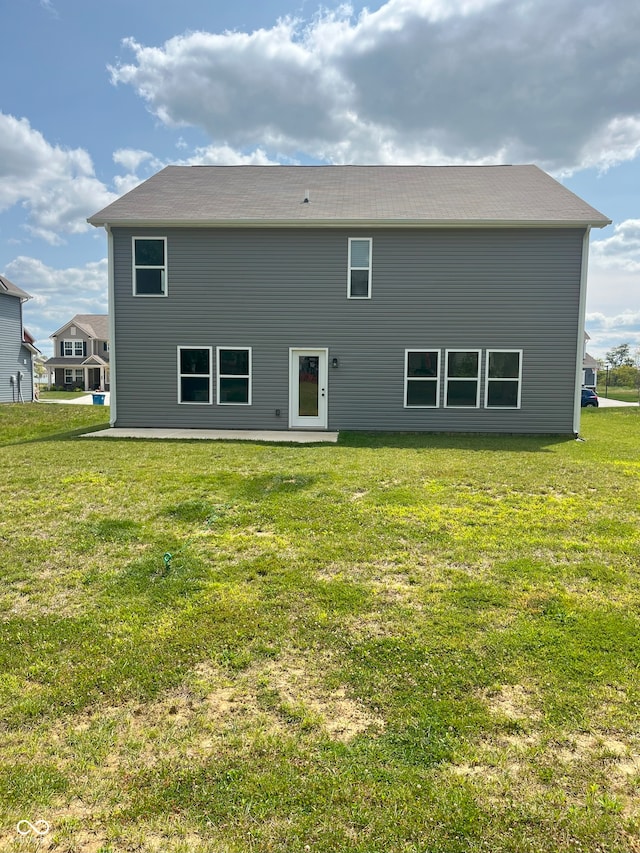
[0,0,640,357]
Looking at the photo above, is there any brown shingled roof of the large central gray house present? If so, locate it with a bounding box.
[88,166,611,228]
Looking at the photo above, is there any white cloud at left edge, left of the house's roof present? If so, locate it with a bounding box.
[0,113,115,244]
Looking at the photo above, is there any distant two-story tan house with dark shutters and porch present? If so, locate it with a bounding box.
[45,314,110,391]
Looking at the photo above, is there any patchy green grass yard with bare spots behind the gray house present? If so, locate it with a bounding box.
[0,405,640,853]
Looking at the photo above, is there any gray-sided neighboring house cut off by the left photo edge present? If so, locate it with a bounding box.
[0,276,40,403]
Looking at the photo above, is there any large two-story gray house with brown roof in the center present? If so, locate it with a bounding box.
[89,166,610,438]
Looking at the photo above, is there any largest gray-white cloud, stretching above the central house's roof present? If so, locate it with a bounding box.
[111,0,640,174]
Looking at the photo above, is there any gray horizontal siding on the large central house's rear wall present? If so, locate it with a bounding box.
[114,229,583,433]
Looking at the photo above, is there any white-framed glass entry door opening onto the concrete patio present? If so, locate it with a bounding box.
[289,349,328,429]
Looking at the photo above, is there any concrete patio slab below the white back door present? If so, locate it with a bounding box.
[81,427,338,444]
